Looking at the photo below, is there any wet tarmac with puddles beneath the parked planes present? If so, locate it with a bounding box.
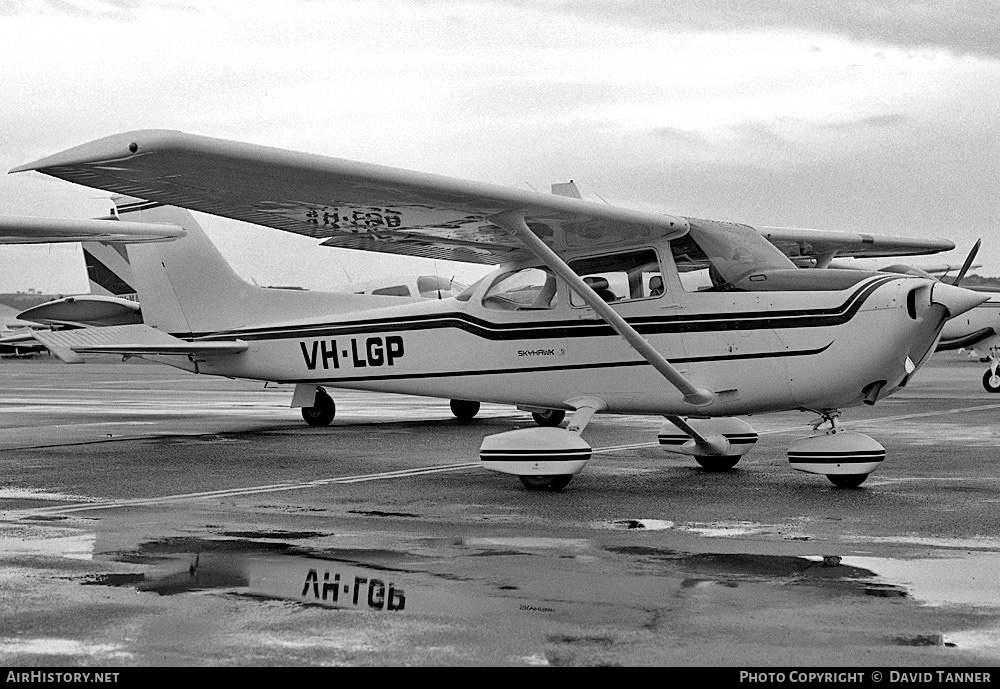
[0,353,1000,667]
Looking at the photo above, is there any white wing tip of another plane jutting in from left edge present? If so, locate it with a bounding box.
[0,216,185,244]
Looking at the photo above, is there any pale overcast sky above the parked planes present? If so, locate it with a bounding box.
[0,0,1000,293]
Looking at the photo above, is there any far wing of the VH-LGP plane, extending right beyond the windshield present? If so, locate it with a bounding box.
[757,227,955,268]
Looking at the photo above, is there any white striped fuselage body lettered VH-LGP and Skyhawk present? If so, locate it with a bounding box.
[189,260,946,416]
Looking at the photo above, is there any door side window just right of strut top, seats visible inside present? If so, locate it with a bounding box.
[569,249,663,306]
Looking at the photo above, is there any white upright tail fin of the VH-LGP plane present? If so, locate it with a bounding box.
[114,197,386,337]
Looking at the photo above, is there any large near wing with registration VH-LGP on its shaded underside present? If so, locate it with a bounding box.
[11,130,687,264]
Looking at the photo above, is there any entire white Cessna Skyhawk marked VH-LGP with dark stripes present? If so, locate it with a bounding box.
[3,130,985,490]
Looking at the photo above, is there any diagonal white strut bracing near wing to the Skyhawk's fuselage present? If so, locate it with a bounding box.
[489,212,715,407]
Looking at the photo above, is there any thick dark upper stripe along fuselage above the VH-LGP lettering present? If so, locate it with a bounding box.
[188,277,902,341]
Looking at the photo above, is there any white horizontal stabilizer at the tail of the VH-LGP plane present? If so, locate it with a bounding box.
[35,325,248,363]
